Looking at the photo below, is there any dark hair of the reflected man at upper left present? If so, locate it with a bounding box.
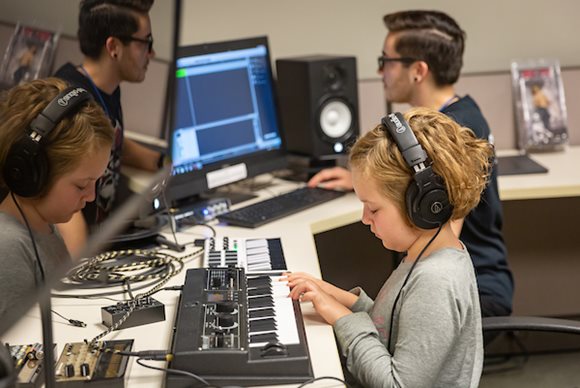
[77,0,155,59]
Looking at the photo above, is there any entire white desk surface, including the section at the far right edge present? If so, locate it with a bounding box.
[2,147,580,387]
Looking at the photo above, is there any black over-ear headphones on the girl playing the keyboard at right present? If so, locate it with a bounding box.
[381,112,453,229]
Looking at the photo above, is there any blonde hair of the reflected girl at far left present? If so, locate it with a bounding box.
[0,78,114,197]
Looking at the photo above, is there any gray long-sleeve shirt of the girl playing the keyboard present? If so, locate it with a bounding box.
[334,248,483,388]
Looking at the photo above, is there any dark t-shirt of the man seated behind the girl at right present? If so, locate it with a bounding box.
[441,96,513,313]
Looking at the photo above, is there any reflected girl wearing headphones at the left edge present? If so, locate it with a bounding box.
[0,78,113,316]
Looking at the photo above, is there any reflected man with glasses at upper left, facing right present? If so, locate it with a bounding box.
[55,0,162,253]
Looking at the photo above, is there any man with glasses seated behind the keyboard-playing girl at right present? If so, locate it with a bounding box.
[309,11,513,330]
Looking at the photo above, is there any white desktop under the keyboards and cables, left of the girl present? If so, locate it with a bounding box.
[2,180,360,388]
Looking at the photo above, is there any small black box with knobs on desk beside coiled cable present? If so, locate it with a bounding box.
[101,296,165,330]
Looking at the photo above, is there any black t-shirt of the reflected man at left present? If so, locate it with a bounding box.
[55,63,123,225]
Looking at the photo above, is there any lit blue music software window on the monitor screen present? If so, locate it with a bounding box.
[173,46,281,173]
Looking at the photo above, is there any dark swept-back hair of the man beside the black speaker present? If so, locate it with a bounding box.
[383,10,465,86]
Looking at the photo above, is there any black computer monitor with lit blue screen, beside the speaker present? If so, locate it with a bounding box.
[168,36,286,205]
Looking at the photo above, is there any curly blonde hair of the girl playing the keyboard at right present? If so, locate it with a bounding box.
[349,108,494,223]
